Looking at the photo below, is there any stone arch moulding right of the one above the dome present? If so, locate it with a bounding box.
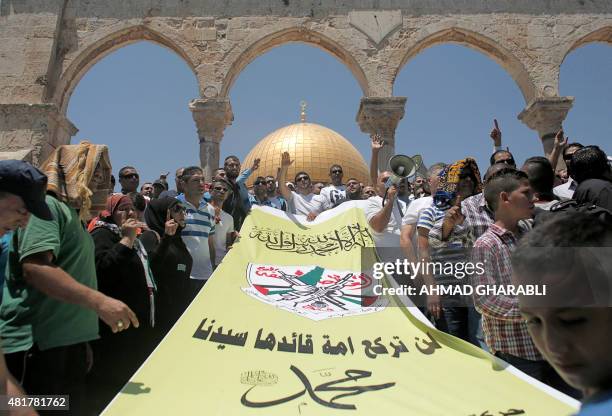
[393,27,536,103]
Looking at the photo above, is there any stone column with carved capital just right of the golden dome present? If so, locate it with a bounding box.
[357,97,406,171]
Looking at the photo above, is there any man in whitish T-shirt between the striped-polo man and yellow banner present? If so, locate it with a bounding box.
[208,177,236,265]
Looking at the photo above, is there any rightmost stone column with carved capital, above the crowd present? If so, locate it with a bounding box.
[518,97,574,158]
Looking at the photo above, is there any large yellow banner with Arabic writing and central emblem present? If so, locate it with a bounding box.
[103,204,577,416]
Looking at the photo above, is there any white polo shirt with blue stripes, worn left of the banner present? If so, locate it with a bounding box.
[176,194,215,280]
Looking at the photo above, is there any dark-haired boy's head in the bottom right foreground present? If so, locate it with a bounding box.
[512,212,612,416]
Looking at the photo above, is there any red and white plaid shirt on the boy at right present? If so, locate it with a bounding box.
[472,224,543,361]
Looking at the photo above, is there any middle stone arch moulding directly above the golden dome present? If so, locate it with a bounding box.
[219,27,370,97]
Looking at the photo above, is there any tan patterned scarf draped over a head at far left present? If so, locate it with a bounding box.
[40,141,111,220]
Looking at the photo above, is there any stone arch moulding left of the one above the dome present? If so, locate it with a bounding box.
[53,25,197,114]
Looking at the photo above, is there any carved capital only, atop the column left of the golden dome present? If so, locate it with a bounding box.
[189,98,234,143]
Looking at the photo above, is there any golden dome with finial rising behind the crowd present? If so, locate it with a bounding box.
[242,119,370,188]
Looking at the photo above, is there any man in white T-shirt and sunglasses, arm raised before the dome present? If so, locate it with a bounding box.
[278,152,323,221]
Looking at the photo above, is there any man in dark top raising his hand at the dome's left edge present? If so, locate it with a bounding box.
[223,155,259,230]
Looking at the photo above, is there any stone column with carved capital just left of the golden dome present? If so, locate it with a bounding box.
[189,98,234,181]
